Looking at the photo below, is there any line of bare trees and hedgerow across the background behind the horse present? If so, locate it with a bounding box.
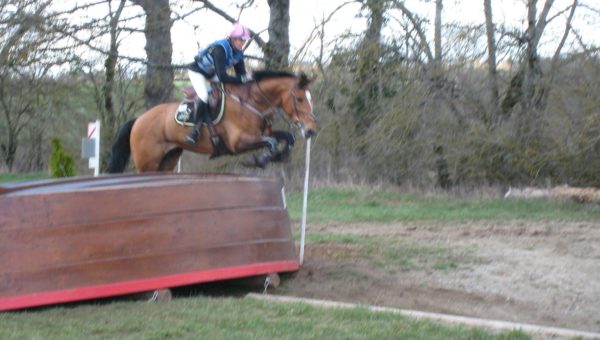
[0,0,600,189]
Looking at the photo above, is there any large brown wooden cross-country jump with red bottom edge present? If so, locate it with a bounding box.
[0,174,299,310]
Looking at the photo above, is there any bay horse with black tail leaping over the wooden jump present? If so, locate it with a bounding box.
[109,71,317,173]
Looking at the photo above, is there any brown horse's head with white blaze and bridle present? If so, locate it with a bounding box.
[281,74,317,138]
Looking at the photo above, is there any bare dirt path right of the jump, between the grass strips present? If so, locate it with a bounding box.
[276,221,600,332]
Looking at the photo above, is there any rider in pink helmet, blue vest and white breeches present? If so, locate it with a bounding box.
[186,22,251,144]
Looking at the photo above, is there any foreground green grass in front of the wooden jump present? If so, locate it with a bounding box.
[0,297,529,339]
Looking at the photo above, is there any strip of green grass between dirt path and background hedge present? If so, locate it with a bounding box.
[288,188,600,223]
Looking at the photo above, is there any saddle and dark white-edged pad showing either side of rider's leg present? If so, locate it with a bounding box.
[175,82,225,126]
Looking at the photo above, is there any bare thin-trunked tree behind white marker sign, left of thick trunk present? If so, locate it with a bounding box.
[45,0,149,170]
